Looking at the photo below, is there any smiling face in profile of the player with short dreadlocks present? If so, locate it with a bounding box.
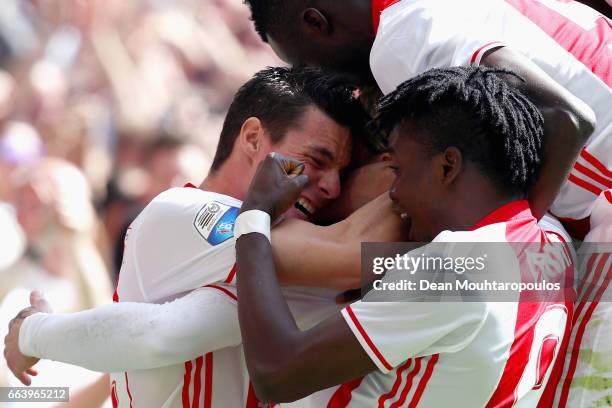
[389,125,442,242]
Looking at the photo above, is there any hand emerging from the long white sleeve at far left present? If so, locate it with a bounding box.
[4,291,51,385]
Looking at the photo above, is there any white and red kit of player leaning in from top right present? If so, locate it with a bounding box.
[370,0,612,407]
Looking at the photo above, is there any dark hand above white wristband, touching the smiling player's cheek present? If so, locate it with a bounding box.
[241,153,308,222]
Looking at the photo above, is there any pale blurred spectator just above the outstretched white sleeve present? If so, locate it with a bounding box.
[0,159,111,311]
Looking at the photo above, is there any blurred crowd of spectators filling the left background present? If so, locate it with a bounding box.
[0,0,280,398]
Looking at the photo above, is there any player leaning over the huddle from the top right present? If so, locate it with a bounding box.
[246,0,612,407]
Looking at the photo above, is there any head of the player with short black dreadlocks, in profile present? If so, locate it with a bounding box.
[380,67,543,241]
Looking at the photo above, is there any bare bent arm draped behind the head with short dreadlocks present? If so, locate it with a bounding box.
[481,47,595,219]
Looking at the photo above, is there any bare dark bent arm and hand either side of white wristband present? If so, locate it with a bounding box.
[236,156,376,402]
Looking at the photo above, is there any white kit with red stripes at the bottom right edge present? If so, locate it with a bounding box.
[553,190,612,408]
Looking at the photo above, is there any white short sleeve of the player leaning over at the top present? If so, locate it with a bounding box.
[370,0,505,94]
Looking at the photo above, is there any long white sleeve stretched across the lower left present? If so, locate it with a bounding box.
[19,288,241,372]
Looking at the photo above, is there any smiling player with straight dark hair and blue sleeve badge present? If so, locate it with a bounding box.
[5,68,401,408]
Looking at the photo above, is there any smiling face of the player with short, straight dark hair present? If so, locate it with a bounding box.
[271,107,352,219]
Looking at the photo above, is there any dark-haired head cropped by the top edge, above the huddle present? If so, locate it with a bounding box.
[245,0,374,83]
